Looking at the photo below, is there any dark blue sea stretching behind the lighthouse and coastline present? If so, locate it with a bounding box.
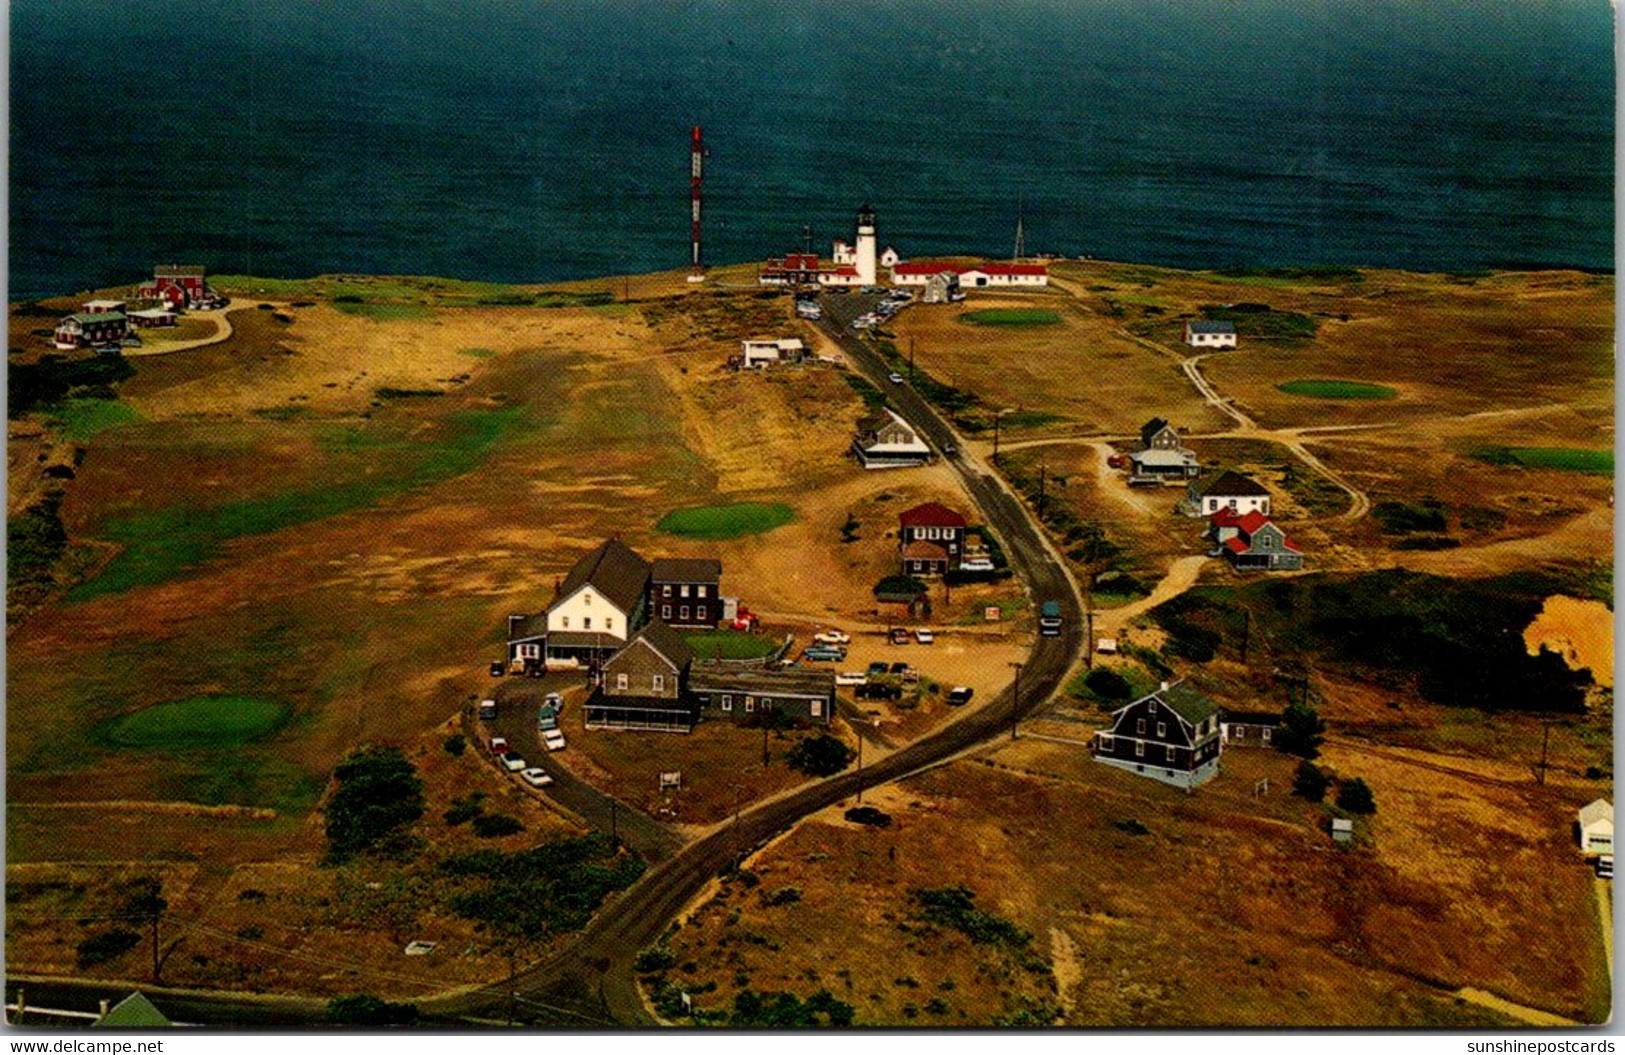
[10,0,1614,297]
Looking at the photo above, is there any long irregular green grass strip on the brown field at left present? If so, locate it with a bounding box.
[68,406,522,601]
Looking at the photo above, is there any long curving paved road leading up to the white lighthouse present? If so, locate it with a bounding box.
[424,294,1082,1026]
